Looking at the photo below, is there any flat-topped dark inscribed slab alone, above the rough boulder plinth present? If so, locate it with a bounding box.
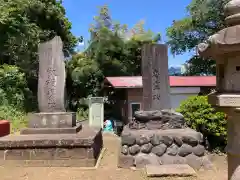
[142,44,171,111]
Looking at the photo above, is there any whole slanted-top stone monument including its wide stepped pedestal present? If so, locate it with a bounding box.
[0,37,102,166]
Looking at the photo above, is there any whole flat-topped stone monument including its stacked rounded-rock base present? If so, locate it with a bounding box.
[118,44,211,169]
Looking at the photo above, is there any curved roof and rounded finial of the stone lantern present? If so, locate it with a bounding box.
[197,0,240,58]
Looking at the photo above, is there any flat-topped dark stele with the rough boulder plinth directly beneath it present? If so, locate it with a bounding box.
[129,44,185,130]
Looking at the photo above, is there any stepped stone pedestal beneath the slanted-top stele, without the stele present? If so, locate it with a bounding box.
[0,112,103,167]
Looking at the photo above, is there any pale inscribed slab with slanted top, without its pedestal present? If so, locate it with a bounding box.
[38,36,66,112]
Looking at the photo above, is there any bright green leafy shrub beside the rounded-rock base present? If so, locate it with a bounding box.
[177,96,227,149]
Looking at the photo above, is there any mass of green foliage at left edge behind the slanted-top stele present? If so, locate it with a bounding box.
[0,0,78,131]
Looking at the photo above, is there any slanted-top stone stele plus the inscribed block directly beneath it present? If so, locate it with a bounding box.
[24,36,76,132]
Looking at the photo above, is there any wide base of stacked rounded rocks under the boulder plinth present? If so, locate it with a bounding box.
[118,126,212,170]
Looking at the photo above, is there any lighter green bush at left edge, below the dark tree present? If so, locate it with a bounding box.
[0,65,31,133]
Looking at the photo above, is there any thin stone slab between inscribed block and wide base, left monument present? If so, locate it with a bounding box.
[20,124,82,134]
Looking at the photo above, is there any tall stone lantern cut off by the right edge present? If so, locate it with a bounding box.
[198,0,240,180]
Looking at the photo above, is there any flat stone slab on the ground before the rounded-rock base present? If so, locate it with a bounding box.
[146,164,197,177]
